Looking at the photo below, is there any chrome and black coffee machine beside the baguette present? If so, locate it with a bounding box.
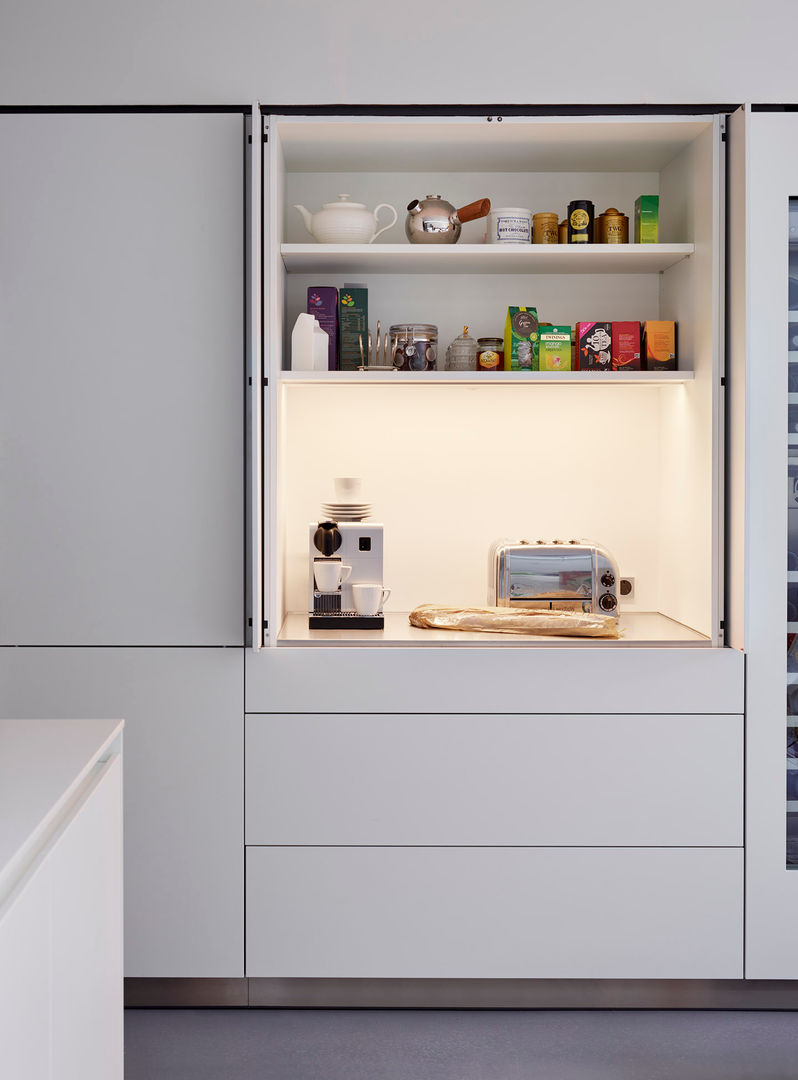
[308,522,386,630]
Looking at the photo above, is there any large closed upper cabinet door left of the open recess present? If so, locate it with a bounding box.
[0,114,244,645]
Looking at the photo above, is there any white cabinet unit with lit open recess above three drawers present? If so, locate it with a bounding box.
[240,109,744,978]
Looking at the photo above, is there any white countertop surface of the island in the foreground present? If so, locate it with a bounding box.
[0,720,124,906]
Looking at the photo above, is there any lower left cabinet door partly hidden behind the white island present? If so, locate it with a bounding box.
[0,649,244,978]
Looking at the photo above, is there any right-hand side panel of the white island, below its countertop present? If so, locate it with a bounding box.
[49,757,124,1080]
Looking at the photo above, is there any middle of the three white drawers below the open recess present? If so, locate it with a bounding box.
[246,714,743,847]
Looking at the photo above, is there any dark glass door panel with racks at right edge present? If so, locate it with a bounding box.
[786,198,798,869]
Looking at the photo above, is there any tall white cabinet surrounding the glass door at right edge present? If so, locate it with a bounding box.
[730,107,798,978]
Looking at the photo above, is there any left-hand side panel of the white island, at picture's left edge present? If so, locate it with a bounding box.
[0,864,53,1080]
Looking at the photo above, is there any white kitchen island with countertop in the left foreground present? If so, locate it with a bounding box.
[0,719,123,1080]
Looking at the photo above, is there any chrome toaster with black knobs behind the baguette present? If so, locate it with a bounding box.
[488,540,620,617]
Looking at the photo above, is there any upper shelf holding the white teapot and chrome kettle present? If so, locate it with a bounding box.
[280,243,695,274]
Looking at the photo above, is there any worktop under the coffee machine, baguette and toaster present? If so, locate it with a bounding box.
[278,611,712,649]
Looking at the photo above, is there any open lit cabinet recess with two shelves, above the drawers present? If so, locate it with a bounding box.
[263,116,725,648]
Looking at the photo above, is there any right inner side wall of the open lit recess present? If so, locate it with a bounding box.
[649,120,723,640]
